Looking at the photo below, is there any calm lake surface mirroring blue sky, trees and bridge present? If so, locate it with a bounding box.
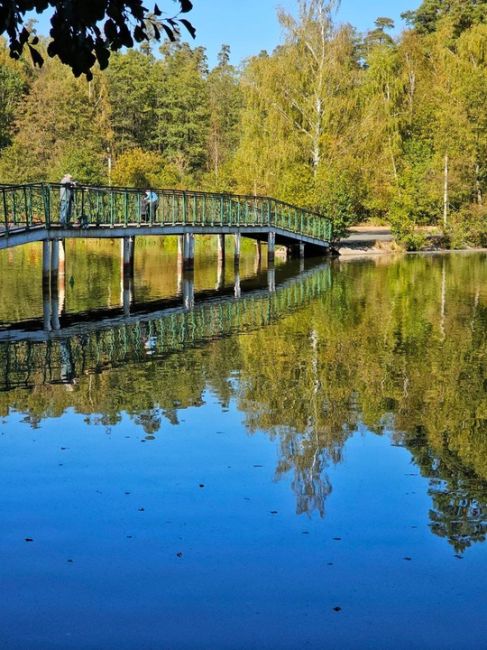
[0,241,487,650]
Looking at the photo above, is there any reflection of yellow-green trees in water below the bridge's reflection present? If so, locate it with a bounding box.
[0,257,487,552]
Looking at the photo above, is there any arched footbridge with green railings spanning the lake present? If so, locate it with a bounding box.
[0,183,333,259]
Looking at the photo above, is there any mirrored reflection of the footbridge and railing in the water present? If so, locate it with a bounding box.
[0,265,331,391]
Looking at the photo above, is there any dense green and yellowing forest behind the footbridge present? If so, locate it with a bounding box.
[0,0,487,248]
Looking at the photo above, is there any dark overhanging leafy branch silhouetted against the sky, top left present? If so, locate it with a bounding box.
[0,0,195,79]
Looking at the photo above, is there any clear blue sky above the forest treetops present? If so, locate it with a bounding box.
[29,0,421,66]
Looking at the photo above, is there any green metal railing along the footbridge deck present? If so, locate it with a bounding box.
[0,183,333,241]
